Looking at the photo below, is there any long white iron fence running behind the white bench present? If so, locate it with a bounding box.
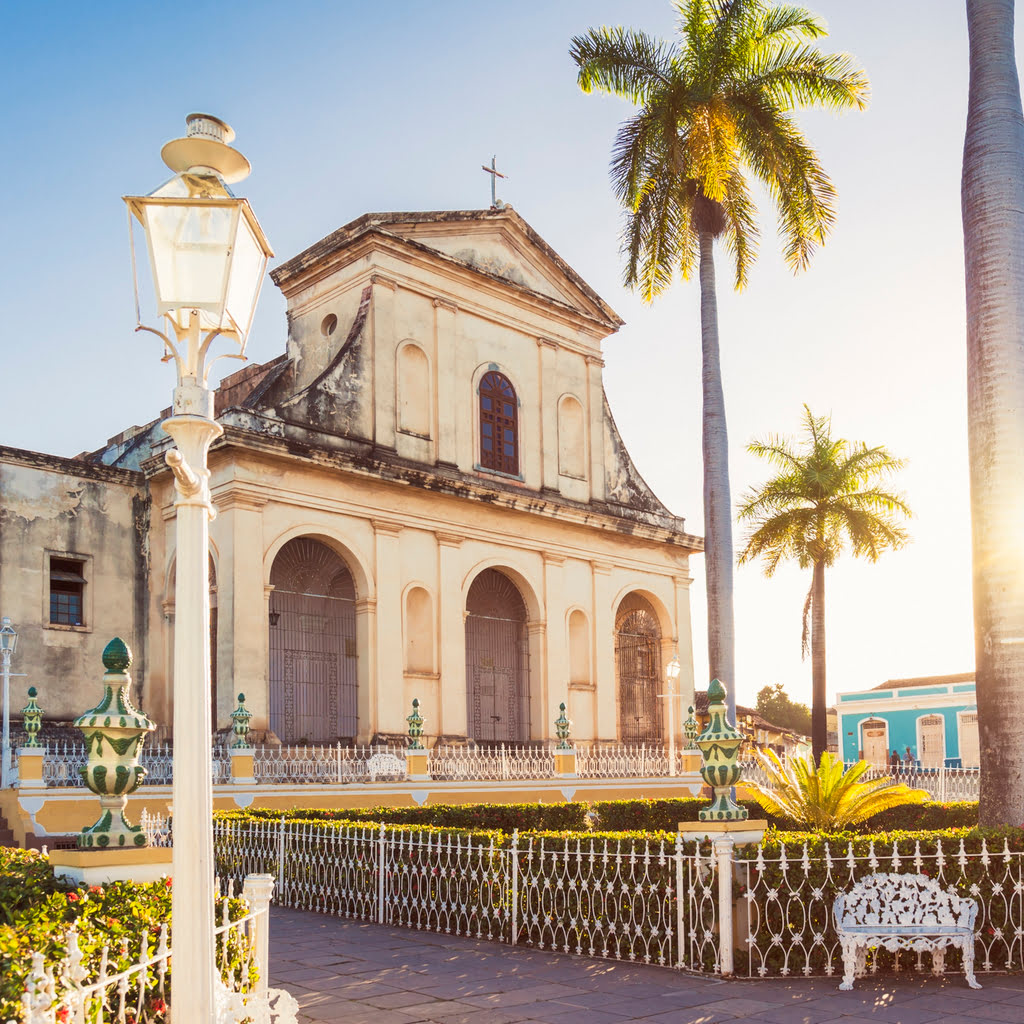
[214,818,1024,977]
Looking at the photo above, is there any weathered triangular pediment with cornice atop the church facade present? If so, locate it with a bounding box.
[271,207,622,330]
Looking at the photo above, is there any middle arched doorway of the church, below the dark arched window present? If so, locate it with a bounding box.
[466,569,529,742]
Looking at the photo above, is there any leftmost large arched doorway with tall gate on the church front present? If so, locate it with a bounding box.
[269,537,358,743]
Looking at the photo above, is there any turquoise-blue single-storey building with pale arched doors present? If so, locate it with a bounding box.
[836,672,979,768]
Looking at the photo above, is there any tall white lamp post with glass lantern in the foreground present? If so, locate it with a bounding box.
[125,114,273,1024]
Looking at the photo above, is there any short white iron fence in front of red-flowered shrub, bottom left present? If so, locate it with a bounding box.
[8,879,298,1024]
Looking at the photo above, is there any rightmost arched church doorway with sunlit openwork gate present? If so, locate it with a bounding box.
[615,594,664,743]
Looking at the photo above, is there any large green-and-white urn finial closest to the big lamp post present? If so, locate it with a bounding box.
[72,637,157,849]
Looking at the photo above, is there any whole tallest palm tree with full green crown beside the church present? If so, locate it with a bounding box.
[569,0,868,719]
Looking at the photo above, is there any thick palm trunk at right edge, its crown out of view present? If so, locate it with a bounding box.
[961,0,1024,825]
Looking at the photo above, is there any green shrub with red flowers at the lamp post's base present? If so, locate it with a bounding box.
[0,847,255,1021]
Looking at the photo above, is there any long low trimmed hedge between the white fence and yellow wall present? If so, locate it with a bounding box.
[232,804,587,833]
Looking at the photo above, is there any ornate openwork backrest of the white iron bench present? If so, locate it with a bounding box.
[833,872,978,929]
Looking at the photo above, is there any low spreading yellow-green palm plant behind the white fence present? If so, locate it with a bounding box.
[744,751,931,831]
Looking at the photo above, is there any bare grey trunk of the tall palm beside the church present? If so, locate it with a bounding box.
[699,230,736,725]
